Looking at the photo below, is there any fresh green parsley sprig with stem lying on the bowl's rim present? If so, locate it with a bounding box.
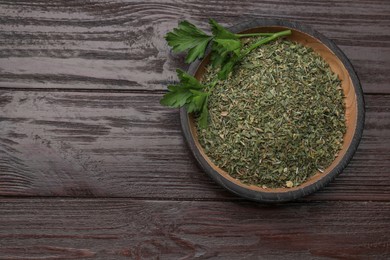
[160,19,291,128]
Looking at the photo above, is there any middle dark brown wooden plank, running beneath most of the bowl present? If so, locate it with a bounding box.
[0,91,390,201]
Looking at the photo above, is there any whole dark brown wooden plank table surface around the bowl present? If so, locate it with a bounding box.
[0,0,390,259]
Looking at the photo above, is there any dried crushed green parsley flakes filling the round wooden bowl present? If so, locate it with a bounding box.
[198,39,346,188]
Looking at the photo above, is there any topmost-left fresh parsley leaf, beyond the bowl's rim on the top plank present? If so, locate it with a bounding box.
[165,21,213,63]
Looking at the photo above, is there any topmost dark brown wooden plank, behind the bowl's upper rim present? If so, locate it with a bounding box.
[0,0,390,93]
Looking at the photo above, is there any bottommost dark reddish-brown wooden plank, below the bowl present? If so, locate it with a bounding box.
[0,198,390,259]
